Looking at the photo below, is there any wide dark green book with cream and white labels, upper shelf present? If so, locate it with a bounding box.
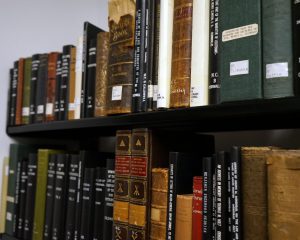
[218,0,265,102]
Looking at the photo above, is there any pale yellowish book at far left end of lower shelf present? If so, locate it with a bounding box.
[0,157,9,233]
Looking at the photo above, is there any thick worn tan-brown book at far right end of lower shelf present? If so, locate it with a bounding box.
[267,150,300,240]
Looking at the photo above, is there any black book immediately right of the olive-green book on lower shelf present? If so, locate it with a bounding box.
[44,154,56,240]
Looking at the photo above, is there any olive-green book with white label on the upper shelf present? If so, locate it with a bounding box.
[22,58,32,124]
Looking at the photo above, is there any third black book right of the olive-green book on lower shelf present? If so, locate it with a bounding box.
[65,154,79,240]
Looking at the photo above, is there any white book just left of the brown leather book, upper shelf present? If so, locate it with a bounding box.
[157,0,174,108]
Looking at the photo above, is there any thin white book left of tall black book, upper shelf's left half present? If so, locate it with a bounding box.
[74,36,83,119]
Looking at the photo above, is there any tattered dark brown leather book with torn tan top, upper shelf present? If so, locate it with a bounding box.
[106,0,135,114]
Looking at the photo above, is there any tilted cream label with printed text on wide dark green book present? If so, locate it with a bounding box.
[222,24,258,42]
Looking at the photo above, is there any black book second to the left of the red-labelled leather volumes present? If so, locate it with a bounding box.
[93,167,107,240]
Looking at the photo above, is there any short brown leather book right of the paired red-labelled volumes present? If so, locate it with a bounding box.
[150,168,169,240]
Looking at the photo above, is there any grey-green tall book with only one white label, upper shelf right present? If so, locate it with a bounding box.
[262,0,294,98]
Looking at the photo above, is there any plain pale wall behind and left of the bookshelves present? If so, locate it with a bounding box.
[0,0,108,191]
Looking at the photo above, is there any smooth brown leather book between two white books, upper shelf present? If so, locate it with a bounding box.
[170,0,193,108]
